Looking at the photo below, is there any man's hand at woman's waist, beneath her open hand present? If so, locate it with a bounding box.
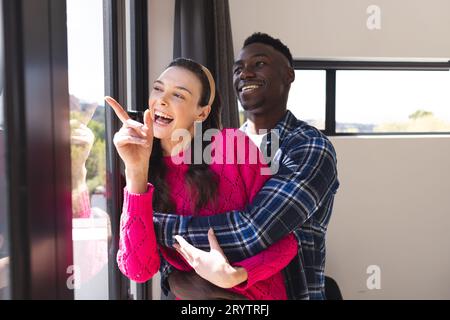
[168,270,248,300]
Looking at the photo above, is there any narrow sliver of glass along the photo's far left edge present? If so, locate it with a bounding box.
[0,1,10,300]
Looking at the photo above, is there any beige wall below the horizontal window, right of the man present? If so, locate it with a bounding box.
[326,136,450,299]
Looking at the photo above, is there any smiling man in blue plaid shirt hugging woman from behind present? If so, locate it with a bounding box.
[154,33,339,300]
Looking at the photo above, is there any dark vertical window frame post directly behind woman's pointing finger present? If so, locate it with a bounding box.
[103,0,130,300]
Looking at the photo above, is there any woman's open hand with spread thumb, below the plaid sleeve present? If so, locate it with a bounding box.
[174,229,248,288]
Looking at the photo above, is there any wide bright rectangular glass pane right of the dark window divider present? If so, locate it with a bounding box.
[336,70,450,133]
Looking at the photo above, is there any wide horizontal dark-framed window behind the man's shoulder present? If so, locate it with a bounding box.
[288,61,450,135]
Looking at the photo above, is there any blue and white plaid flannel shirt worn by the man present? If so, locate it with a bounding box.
[154,111,339,300]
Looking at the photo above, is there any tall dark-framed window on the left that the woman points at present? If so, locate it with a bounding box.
[0,0,142,300]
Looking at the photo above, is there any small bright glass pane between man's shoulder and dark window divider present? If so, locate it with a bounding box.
[288,70,326,130]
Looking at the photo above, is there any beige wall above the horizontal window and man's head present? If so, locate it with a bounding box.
[229,0,450,60]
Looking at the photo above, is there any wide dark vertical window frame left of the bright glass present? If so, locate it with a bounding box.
[2,0,74,299]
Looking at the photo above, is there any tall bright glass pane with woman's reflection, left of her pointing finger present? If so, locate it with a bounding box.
[67,0,111,299]
